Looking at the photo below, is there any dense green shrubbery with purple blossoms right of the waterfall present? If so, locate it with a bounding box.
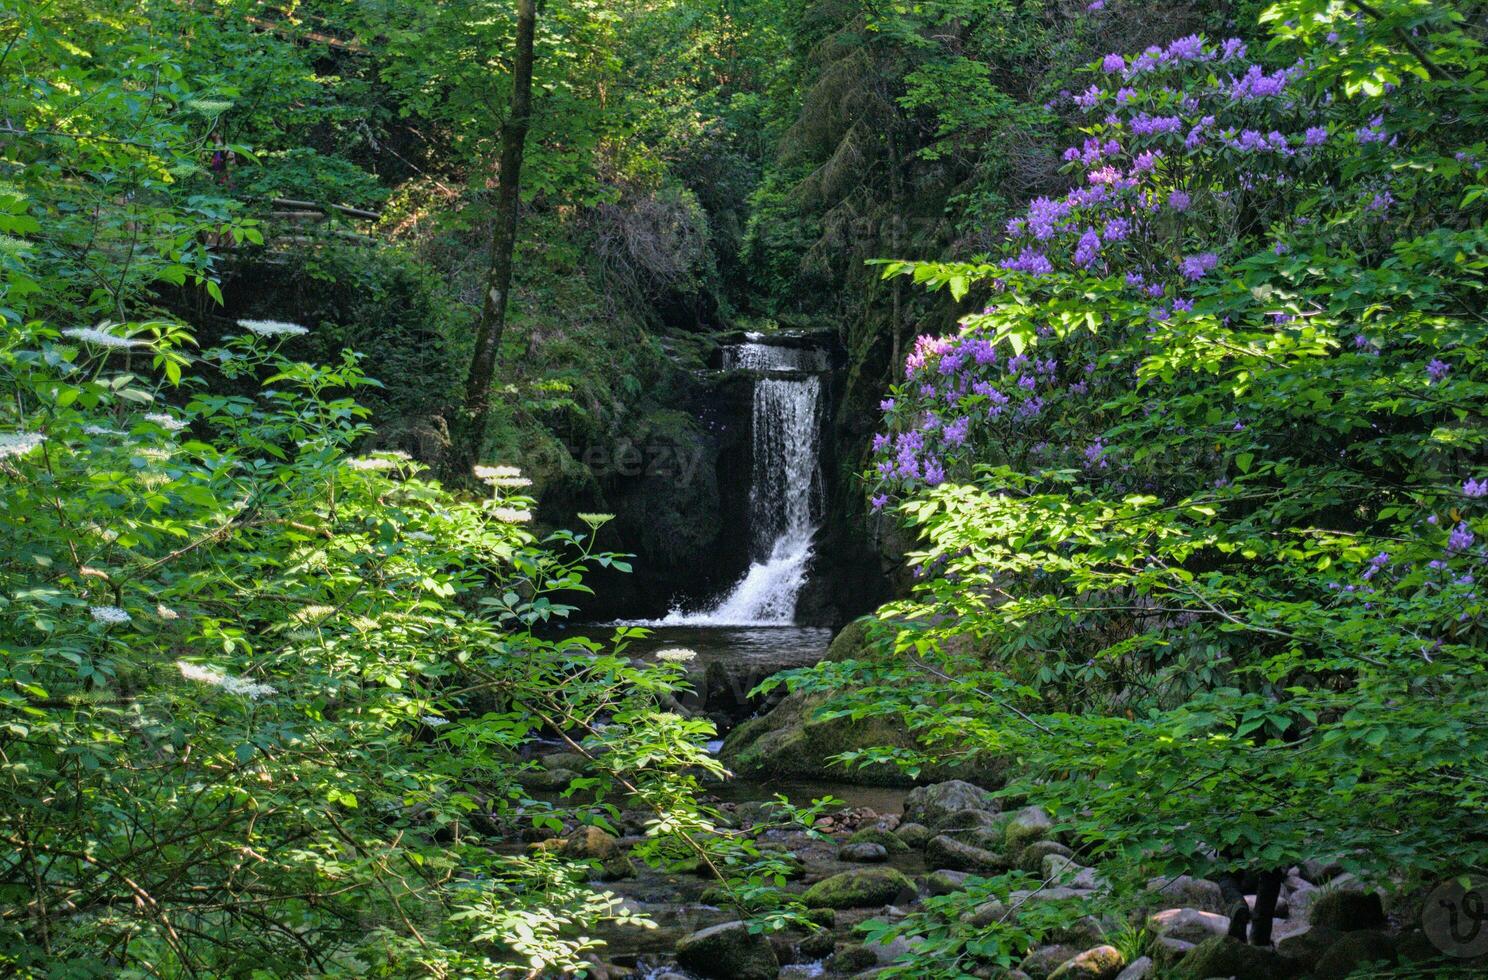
[779,1,1488,963]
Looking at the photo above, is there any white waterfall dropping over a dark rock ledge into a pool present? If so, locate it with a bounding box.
[662,344,826,626]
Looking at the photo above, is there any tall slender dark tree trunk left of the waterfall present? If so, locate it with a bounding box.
[451,0,537,476]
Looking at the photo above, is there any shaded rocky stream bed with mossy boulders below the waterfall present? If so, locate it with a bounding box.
[514,626,1464,980]
